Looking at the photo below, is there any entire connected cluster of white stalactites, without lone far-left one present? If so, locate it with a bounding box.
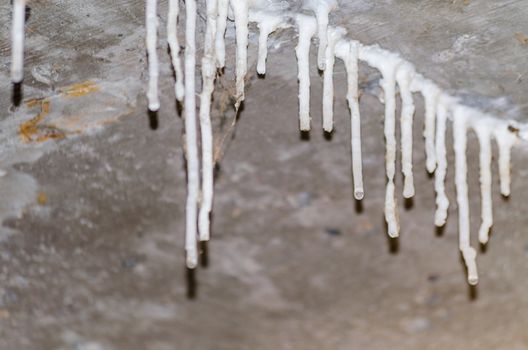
[147,0,517,284]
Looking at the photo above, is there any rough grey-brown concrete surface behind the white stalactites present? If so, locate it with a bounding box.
[0,0,528,350]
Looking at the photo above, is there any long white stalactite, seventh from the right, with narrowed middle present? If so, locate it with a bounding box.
[359,46,402,238]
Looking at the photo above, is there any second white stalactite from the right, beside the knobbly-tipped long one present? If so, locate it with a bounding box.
[473,120,493,244]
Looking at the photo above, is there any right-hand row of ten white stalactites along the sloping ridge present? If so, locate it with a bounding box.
[290,8,518,285]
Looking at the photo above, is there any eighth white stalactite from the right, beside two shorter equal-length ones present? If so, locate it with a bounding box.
[335,40,365,200]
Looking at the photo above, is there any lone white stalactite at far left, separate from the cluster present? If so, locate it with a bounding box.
[11,0,27,83]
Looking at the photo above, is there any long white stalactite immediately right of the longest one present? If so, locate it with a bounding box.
[198,0,218,241]
